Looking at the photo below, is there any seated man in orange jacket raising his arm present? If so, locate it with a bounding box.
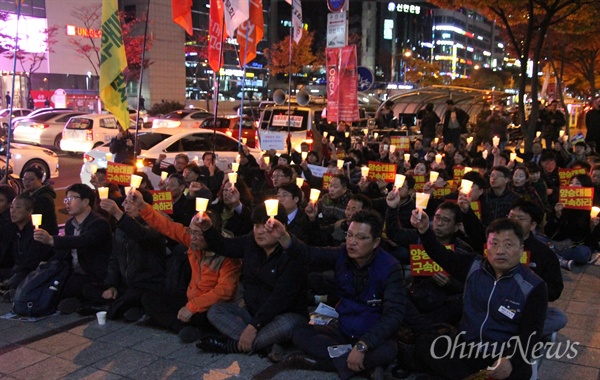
[129,191,241,343]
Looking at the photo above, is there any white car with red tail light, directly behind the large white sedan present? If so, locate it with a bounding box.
[60,114,135,153]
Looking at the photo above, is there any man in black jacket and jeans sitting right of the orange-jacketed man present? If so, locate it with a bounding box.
[196,204,308,353]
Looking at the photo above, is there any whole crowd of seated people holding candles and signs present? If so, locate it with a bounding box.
[0,116,600,379]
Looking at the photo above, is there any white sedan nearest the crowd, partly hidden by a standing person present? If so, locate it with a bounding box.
[80,128,261,188]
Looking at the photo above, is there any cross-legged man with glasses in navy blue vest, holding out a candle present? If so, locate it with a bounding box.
[262,210,406,379]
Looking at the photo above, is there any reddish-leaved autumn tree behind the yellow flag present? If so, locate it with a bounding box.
[69,4,154,82]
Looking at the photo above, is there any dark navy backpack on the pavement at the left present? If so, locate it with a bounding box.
[13,260,71,317]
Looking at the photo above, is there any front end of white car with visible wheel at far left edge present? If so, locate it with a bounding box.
[0,143,59,181]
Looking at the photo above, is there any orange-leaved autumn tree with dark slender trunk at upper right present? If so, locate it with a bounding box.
[431,0,597,150]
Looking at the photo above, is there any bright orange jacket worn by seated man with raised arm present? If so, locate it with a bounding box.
[140,205,242,314]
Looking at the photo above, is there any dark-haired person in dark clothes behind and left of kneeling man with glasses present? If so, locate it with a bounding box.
[21,166,58,235]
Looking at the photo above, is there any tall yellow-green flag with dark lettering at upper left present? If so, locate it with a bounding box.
[100,0,129,130]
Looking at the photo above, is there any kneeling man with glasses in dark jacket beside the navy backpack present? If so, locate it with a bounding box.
[33,183,112,314]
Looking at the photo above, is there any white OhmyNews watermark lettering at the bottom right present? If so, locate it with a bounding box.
[429,331,580,370]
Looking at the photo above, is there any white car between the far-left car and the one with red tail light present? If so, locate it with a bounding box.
[13,110,84,149]
